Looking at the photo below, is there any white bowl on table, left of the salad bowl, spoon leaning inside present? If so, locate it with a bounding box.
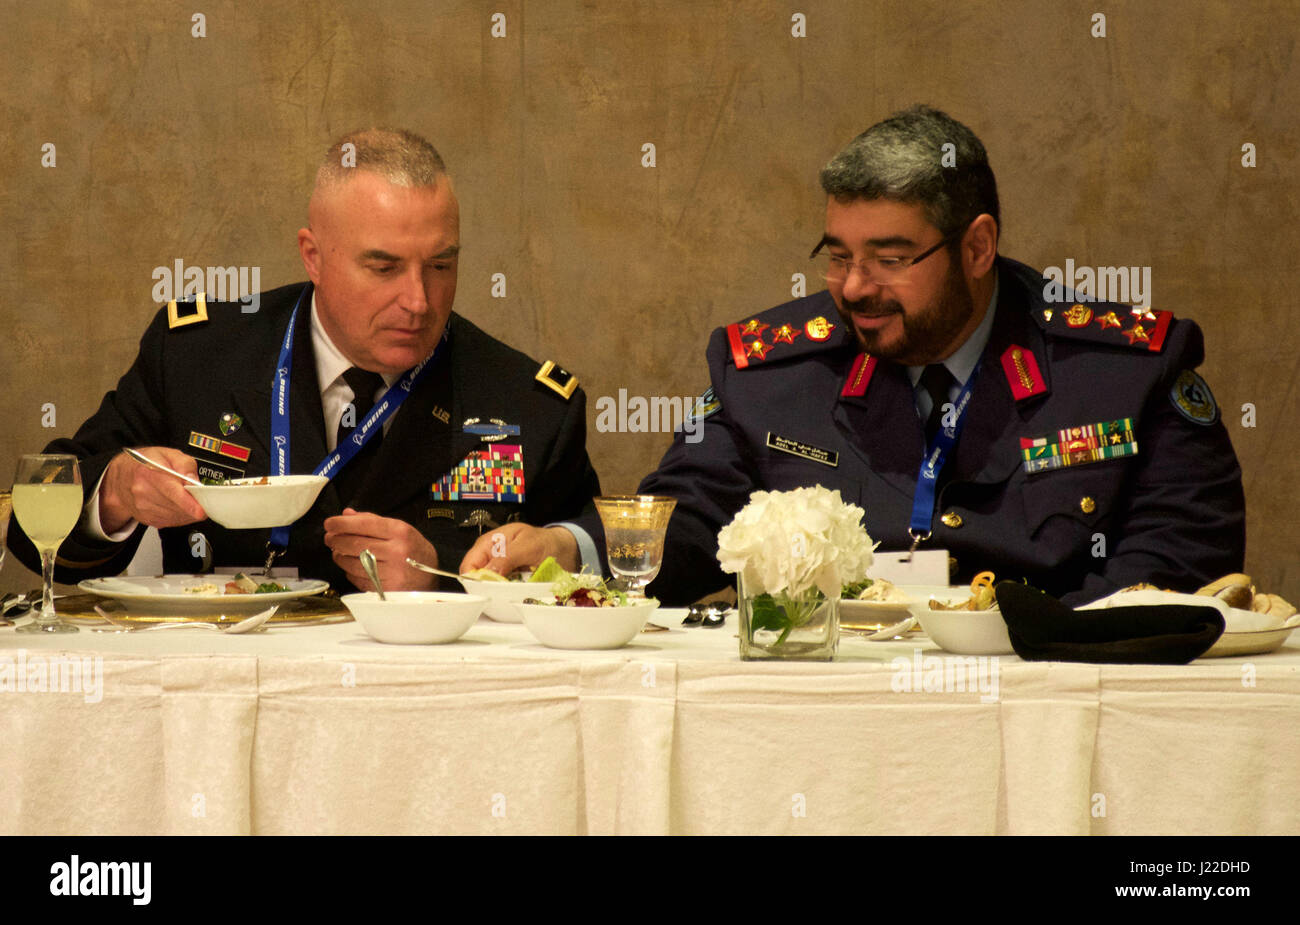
[342,591,488,646]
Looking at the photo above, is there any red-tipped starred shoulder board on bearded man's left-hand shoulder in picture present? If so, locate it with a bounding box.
[727,292,853,369]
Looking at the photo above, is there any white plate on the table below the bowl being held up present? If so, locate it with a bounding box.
[77,574,329,616]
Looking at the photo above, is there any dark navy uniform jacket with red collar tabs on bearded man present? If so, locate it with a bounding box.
[582,259,1245,604]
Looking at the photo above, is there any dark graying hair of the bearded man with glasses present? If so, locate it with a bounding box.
[820,105,1002,236]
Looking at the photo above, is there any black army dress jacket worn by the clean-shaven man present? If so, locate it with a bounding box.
[10,283,601,591]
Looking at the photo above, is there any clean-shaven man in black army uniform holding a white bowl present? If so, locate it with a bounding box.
[10,131,599,591]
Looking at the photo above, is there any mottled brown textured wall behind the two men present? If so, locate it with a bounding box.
[0,0,1300,599]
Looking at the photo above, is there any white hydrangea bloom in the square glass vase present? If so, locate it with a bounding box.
[718,485,875,598]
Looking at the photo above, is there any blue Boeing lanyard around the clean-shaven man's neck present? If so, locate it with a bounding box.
[267,283,447,572]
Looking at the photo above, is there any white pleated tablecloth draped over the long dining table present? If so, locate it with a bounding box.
[0,612,1300,834]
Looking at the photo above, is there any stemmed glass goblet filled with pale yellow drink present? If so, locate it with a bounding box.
[13,455,83,633]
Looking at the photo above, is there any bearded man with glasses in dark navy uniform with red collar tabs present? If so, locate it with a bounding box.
[467,108,1245,603]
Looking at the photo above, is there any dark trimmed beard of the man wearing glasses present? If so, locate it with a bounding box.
[836,264,975,366]
